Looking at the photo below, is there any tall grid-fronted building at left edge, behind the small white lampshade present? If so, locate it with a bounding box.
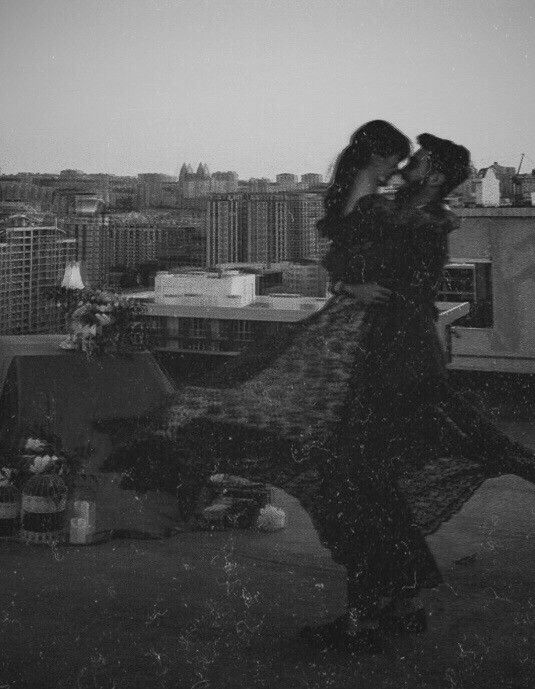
[0,216,76,335]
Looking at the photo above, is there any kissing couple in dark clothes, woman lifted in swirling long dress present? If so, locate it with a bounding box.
[173,120,535,652]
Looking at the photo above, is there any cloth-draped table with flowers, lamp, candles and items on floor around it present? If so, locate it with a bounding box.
[0,266,285,546]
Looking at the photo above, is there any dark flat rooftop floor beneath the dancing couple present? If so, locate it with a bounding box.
[0,412,535,689]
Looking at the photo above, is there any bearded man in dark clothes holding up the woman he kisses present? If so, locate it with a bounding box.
[302,134,469,643]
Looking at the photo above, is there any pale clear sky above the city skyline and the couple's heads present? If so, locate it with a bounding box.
[0,0,535,179]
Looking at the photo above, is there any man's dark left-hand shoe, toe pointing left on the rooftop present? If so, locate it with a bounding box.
[299,616,384,654]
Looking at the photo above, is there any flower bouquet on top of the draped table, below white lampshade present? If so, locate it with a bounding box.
[52,287,147,357]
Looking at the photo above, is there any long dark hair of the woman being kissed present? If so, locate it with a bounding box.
[318,120,411,239]
